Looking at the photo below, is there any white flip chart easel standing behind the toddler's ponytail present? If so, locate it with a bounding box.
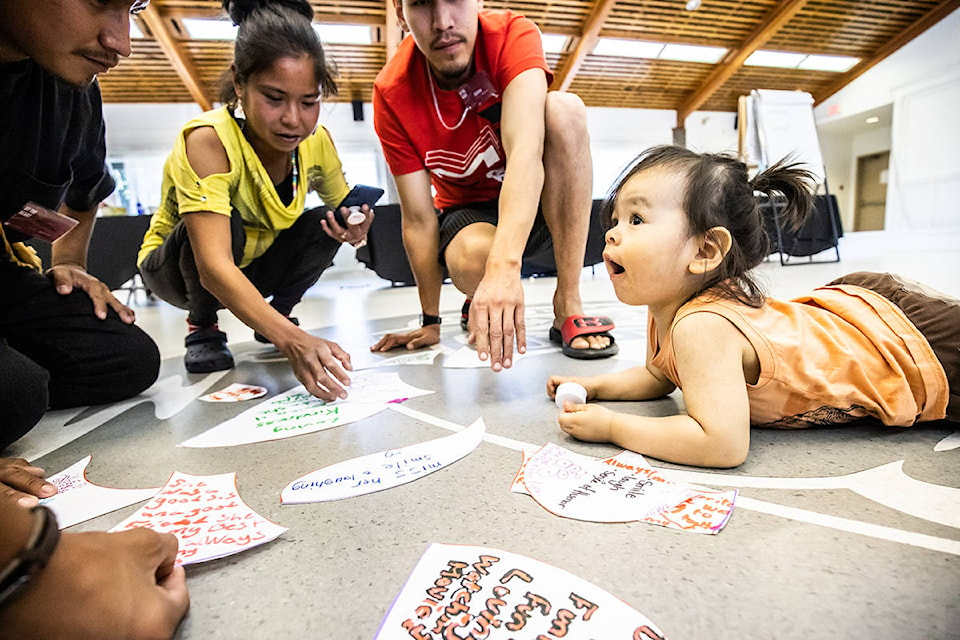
[737,89,840,265]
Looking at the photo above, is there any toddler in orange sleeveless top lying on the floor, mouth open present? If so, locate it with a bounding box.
[547,147,960,467]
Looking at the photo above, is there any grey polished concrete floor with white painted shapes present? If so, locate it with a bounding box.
[14,232,960,640]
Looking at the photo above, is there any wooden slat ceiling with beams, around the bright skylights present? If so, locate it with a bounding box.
[100,0,960,123]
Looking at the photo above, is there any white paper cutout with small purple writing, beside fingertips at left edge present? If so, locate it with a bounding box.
[40,456,160,529]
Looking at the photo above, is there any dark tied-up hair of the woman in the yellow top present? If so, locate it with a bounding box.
[220,0,337,108]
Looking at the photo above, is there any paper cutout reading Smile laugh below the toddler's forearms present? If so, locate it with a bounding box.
[512,444,737,534]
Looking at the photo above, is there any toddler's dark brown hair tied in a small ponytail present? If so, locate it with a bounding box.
[600,145,816,307]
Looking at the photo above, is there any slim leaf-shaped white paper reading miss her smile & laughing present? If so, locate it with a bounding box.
[280,419,486,504]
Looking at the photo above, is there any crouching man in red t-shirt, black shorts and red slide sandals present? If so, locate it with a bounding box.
[371,0,617,371]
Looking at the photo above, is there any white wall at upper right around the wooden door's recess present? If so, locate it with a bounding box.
[815,10,960,229]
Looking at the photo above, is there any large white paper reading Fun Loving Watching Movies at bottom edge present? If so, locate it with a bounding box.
[374,544,665,640]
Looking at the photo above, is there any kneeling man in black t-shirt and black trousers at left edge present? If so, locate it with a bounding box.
[0,0,160,452]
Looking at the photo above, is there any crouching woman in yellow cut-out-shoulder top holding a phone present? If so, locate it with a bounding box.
[138,0,373,400]
